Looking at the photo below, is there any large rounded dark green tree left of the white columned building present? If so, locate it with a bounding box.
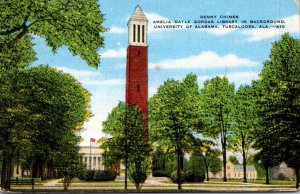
[24,67,91,177]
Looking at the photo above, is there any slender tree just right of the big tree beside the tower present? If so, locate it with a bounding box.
[200,77,234,181]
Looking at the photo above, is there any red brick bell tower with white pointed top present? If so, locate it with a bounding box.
[125,6,149,141]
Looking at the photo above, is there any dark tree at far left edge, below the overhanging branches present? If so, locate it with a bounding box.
[0,70,29,189]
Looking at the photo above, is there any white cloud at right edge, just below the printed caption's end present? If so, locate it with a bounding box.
[242,15,299,42]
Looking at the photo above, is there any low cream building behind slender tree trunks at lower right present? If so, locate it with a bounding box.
[209,161,257,180]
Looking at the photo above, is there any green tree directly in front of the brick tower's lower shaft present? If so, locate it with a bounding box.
[101,103,150,189]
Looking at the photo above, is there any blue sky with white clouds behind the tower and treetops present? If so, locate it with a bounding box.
[31,0,299,145]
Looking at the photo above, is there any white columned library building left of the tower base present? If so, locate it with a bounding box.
[79,145,105,170]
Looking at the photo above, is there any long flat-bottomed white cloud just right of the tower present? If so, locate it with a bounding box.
[149,51,259,70]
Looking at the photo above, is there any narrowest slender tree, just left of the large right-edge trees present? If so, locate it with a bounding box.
[230,86,258,182]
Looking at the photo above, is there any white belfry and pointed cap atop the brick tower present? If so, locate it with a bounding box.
[127,5,148,46]
